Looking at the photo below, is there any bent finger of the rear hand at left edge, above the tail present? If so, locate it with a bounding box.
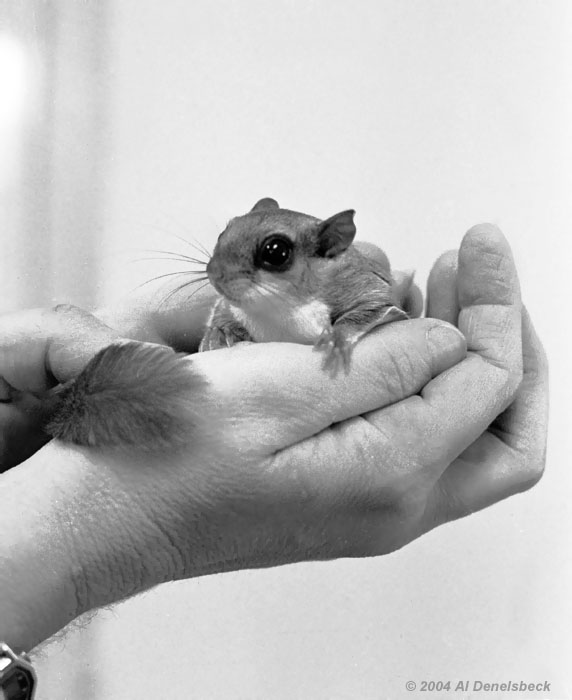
[0,306,118,392]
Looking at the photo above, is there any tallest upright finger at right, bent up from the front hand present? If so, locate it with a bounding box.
[368,226,522,478]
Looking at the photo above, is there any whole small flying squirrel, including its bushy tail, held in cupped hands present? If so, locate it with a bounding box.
[43,198,413,450]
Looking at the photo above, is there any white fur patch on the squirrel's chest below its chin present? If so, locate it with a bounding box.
[230,300,330,344]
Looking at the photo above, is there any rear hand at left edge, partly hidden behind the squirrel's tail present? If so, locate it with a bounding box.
[0,286,215,473]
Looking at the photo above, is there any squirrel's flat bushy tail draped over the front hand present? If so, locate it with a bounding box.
[44,342,205,450]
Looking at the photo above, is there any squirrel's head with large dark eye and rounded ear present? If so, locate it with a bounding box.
[207,197,356,308]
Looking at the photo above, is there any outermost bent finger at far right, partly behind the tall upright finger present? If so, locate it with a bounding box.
[435,312,548,520]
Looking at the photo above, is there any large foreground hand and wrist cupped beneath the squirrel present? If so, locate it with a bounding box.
[0,227,546,648]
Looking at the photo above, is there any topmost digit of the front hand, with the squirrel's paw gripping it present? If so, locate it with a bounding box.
[192,319,465,455]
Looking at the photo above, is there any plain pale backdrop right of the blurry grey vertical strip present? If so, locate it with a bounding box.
[0,0,572,700]
